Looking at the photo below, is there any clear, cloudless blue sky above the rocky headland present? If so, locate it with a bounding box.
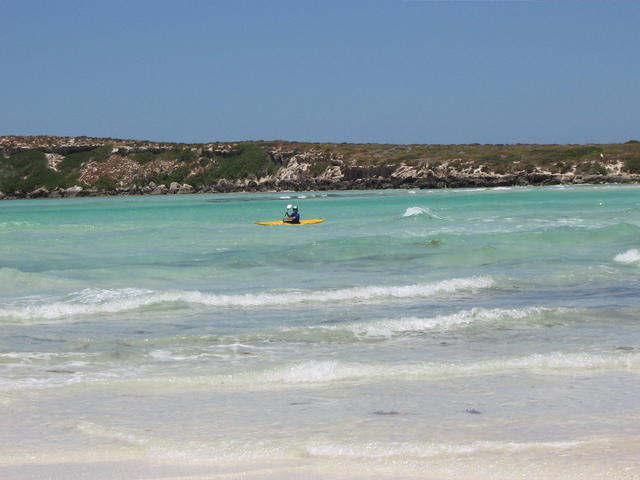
[0,0,640,144]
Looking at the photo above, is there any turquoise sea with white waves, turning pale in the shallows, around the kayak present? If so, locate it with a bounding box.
[0,185,640,480]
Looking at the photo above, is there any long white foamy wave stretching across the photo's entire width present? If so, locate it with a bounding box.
[6,352,640,393]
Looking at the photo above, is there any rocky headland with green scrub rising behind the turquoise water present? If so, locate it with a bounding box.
[0,136,640,199]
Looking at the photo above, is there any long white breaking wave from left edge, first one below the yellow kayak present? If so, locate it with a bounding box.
[0,277,494,321]
